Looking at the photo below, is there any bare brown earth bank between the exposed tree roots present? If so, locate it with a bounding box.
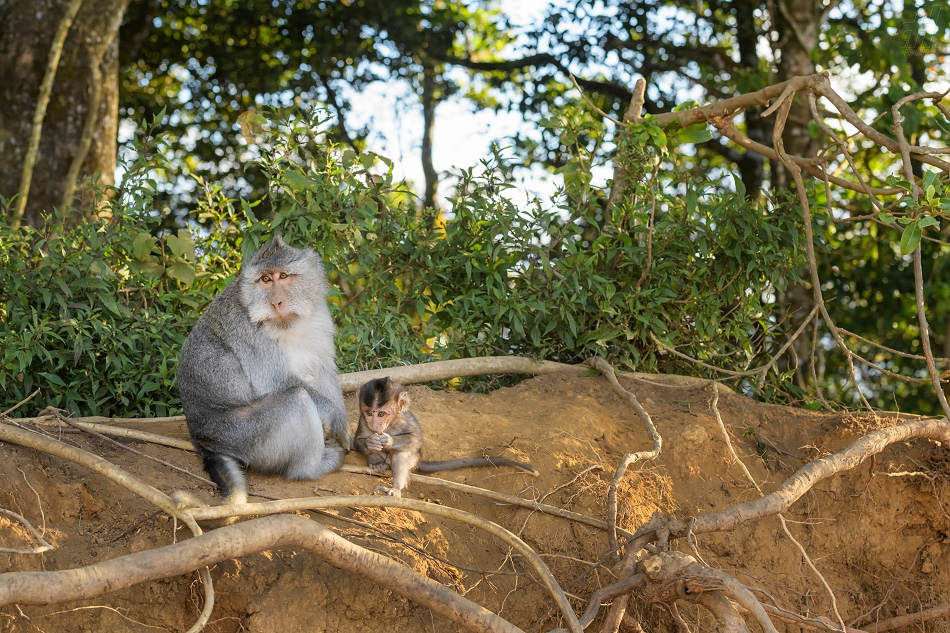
[0,375,950,633]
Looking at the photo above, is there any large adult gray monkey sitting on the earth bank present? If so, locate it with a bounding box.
[178,235,353,504]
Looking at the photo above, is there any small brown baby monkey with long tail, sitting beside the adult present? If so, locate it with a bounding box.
[353,377,538,497]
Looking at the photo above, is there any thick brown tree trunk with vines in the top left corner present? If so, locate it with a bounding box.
[0,0,129,226]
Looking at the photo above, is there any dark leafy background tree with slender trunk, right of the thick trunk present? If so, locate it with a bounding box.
[122,0,504,217]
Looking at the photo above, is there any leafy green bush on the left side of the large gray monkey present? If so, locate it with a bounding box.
[0,115,249,416]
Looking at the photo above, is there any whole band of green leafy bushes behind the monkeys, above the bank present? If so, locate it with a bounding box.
[0,107,802,415]
